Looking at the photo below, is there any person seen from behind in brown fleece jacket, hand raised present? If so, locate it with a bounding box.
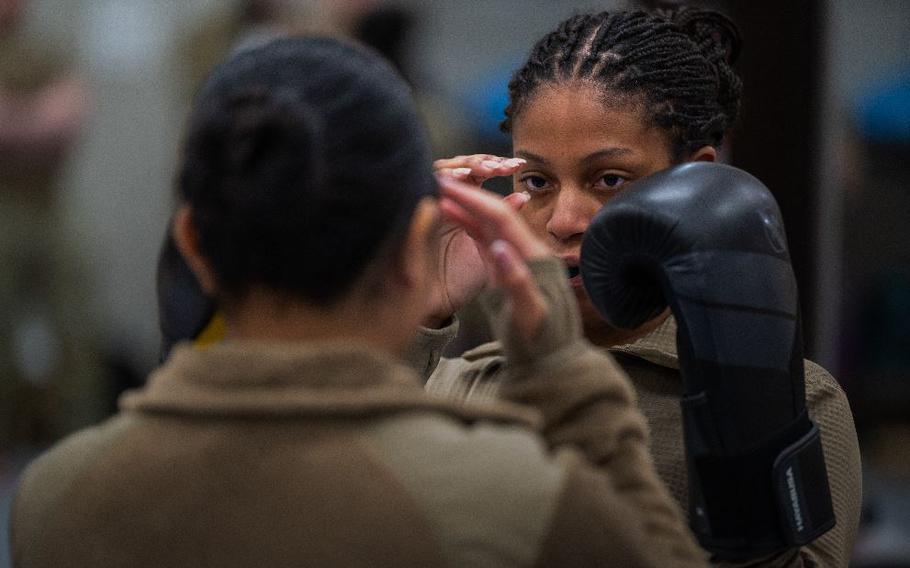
[11,38,704,568]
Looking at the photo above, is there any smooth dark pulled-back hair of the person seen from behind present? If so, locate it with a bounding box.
[177,38,437,305]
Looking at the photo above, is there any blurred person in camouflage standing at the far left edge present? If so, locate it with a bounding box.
[0,0,106,458]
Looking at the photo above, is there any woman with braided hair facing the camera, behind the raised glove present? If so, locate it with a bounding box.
[426,6,860,566]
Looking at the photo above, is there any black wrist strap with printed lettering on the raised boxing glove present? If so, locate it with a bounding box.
[682,406,835,560]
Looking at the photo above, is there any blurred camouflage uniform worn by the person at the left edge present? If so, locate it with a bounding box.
[0,33,108,449]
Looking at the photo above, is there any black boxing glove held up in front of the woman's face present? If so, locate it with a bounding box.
[581,162,835,560]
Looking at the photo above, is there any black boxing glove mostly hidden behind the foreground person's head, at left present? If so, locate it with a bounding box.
[156,225,215,361]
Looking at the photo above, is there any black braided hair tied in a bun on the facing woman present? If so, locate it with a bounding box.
[500,9,742,159]
